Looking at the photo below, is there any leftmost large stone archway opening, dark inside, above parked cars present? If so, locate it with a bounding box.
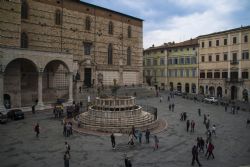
[4,58,38,108]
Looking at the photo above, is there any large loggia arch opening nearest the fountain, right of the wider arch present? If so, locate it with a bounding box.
[43,60,72,103]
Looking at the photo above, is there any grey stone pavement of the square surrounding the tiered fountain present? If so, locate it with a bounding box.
[0,94,250,167]
